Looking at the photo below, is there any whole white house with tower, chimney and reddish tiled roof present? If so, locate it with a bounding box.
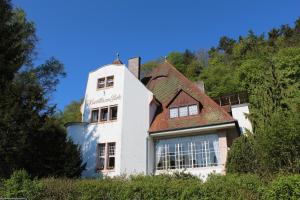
[66,58,244,178]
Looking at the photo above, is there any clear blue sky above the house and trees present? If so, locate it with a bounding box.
[13,0,300,109]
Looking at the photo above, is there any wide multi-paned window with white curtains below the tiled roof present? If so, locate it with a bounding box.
[155,134,220,170]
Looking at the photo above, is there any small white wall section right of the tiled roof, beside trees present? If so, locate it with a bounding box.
[231,103,252,133]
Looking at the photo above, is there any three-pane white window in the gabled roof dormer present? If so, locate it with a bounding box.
[169,104,199,118]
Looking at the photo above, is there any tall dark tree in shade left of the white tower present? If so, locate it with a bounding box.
[0,0,84,178]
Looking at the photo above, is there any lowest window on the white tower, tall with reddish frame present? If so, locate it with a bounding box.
[97,142,116,170]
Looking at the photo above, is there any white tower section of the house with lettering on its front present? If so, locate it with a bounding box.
[67,64,153,177]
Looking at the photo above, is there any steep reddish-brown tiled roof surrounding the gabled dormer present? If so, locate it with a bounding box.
[146,61,236,133]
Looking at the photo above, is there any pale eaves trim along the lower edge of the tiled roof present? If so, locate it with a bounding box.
[150,122,235,137]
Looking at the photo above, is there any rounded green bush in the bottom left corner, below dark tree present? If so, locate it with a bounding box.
[0,170,42,200]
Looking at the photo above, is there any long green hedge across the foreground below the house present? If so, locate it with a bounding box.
[0,172,300,200]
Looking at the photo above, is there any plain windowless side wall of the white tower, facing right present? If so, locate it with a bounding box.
[121,68,153,174]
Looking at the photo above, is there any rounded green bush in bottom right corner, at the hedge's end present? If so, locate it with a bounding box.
[264,174,300,200]
